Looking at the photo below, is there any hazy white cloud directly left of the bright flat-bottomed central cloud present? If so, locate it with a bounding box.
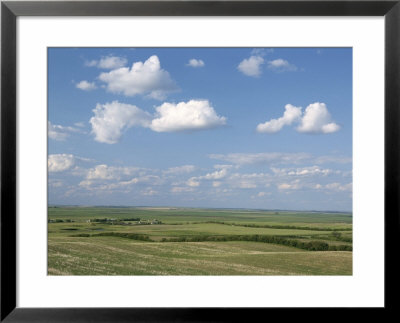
[89,101,151,144]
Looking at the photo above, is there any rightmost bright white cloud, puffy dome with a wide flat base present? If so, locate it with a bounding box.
[297,102,340,133]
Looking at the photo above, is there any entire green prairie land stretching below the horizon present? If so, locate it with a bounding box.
[48,207,352,275]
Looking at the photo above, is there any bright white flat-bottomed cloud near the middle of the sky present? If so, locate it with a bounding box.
[150,100,226,132]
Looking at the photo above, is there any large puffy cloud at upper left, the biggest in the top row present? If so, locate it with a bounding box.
[99,55,177,100]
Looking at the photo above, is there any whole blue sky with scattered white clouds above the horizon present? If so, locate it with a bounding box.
[48,48,352,211]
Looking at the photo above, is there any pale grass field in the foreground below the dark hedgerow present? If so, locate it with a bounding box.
[48,237,352,275]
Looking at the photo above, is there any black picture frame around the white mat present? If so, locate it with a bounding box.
[0,0,400,322]
